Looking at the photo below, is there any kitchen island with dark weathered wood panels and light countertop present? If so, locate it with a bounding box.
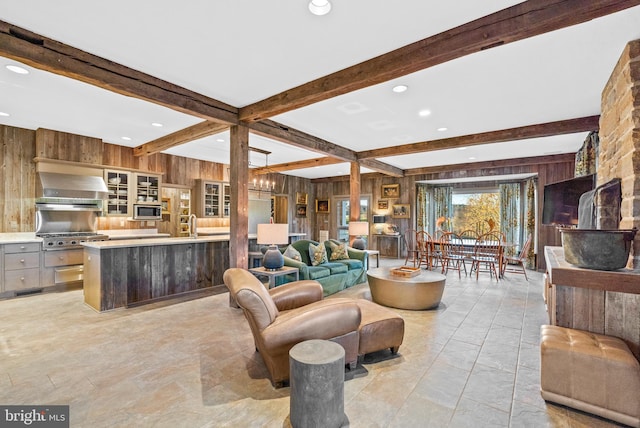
[84,235,229,311]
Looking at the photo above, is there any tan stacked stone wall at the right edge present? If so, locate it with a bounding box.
[598,40,640,270]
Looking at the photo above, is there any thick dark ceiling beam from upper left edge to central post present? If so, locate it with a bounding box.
[0,21,238,125]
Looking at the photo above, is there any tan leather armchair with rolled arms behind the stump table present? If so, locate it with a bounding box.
[223,268,361,387]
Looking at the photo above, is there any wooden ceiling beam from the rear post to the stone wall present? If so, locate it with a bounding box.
[358,115,600,159]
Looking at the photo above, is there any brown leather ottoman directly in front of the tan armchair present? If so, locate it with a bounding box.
[355,299,404,356]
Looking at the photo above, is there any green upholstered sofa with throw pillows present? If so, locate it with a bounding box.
[283,239,367,296]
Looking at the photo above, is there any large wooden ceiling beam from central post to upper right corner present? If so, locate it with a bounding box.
[239,0,640,122]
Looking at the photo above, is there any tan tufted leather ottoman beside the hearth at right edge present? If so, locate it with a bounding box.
[540,325,640,427]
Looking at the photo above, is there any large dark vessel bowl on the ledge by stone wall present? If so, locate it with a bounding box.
[560,228,637,270]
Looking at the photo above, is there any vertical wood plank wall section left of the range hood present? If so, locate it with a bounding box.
[0,125,36,232]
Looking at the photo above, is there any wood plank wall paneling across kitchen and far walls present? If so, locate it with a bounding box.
[0,126,574,264]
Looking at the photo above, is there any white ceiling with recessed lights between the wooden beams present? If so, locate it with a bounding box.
[0,0,640,178]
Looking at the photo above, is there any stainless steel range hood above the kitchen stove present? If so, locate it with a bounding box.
[39,172,108,200]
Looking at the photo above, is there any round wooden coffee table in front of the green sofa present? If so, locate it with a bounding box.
[367,267,447,310]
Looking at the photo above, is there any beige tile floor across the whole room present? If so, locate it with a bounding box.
[0,259,615,428]
